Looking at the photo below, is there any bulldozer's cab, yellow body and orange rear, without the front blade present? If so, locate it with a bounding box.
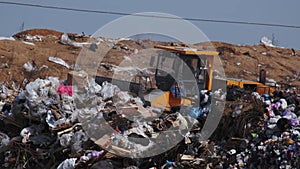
[151,46,275,107]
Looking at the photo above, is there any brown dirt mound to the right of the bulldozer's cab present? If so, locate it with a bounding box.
[212,42,300,85]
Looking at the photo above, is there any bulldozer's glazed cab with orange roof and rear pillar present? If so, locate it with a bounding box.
[155,46,218,96]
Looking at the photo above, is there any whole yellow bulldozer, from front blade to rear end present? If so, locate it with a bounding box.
[96,45,275,107]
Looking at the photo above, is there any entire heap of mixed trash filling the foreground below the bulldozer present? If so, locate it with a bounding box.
[0,72,300,169]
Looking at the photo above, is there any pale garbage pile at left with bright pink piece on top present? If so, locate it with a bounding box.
[0,73,220,169]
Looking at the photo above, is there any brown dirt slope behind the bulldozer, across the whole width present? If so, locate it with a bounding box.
[0,29,300,85]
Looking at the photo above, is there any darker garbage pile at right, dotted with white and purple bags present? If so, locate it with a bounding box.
[204,91,300,168]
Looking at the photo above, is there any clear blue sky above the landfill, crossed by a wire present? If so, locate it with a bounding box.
[0,0,300,49]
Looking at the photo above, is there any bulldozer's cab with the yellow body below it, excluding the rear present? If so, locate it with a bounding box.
[151,46,219,107]
